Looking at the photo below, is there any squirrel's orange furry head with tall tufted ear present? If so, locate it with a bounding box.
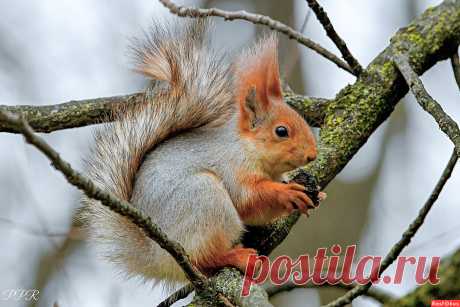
[235,35,316,179]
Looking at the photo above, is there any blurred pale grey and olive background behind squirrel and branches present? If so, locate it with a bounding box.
[0,0,460,307]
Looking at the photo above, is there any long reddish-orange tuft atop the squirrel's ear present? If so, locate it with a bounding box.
[235,34,282,107]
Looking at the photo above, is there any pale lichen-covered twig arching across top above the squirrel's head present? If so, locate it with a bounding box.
[159,0,354,74]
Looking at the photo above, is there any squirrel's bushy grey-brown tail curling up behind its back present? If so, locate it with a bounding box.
[82,19,234,282]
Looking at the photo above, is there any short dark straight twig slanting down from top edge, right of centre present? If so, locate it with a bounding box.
[307,0,363,76]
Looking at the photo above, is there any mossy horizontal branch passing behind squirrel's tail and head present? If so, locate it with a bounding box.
[0,92,328,133]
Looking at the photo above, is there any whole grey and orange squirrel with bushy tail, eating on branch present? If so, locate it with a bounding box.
[83,19,324,282]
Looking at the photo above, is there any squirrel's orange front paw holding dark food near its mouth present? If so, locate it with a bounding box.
[277,183,315,216]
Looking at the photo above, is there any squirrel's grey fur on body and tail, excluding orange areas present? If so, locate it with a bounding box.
[82,20,243,281]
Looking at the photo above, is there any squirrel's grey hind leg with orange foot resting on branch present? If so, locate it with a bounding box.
[169,172,252,274]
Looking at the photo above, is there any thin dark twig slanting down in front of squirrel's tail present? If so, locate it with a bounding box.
[0,110,207,290]
